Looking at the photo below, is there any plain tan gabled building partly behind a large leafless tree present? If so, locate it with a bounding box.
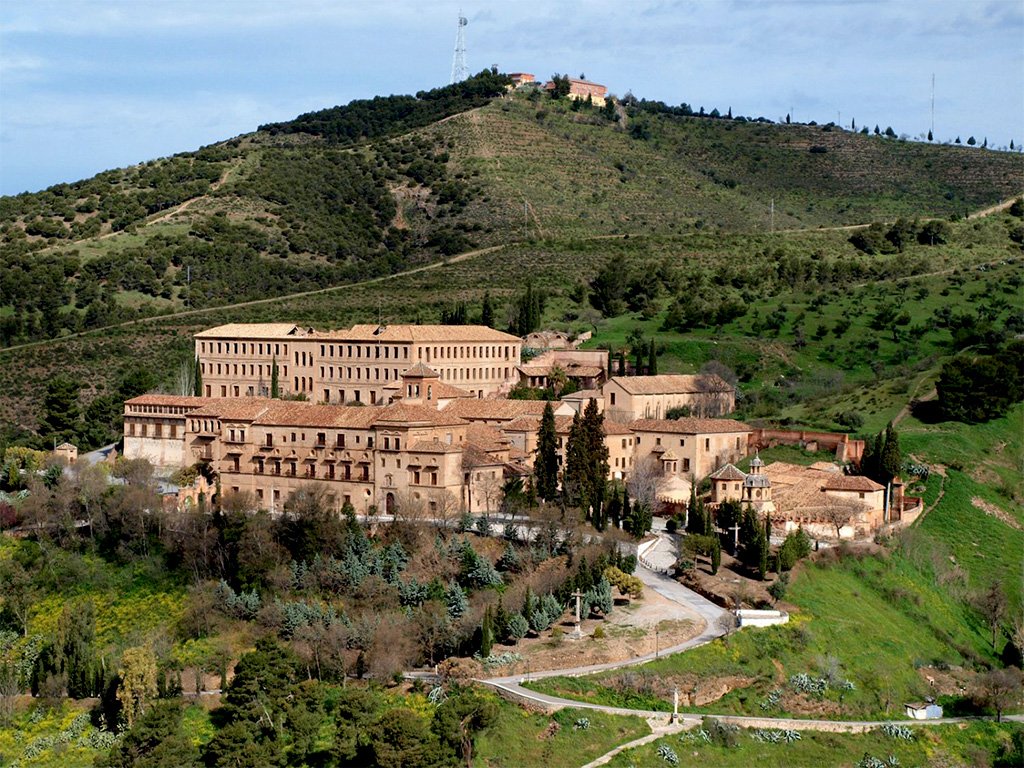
[601,374,736,422]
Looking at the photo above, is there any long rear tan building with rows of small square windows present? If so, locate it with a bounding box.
[196,323,522,406]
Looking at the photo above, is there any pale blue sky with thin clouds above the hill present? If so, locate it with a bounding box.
[0,0,1024,195]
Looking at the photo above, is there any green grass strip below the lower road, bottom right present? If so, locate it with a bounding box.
[608,723,1024,768]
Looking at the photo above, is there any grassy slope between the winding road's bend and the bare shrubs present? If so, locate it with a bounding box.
[529,536,990,719]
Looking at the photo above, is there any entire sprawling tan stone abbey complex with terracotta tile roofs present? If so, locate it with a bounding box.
[124,323,903,537]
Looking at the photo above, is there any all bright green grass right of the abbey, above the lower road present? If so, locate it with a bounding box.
[530,406,1024,718]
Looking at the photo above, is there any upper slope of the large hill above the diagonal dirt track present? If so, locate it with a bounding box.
[0,71,1024,354]
